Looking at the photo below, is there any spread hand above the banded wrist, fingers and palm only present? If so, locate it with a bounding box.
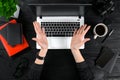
[32,21,48,50]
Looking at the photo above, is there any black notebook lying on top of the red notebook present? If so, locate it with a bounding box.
[7,23,22,46]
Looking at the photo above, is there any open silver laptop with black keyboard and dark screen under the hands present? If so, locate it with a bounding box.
[30,0,91,49]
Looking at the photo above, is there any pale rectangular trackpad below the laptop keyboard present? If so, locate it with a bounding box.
[49,37,67,49]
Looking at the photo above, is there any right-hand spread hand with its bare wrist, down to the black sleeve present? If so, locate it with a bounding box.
[71,25,90,63]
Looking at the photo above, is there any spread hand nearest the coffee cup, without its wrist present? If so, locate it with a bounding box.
[71,25,90,50]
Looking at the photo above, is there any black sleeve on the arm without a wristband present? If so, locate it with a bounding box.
[77,62,94,80]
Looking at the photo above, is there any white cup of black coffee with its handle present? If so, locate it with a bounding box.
[93,23,108,39]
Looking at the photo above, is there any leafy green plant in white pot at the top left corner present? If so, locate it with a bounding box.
[0,0,20,19]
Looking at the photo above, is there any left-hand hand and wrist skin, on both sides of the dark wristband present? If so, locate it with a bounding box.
[32,21,48,65]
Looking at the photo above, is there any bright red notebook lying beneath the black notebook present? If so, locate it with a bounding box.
[0,20,29,56]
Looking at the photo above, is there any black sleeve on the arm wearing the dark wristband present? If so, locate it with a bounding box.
[22,63,43,80]
